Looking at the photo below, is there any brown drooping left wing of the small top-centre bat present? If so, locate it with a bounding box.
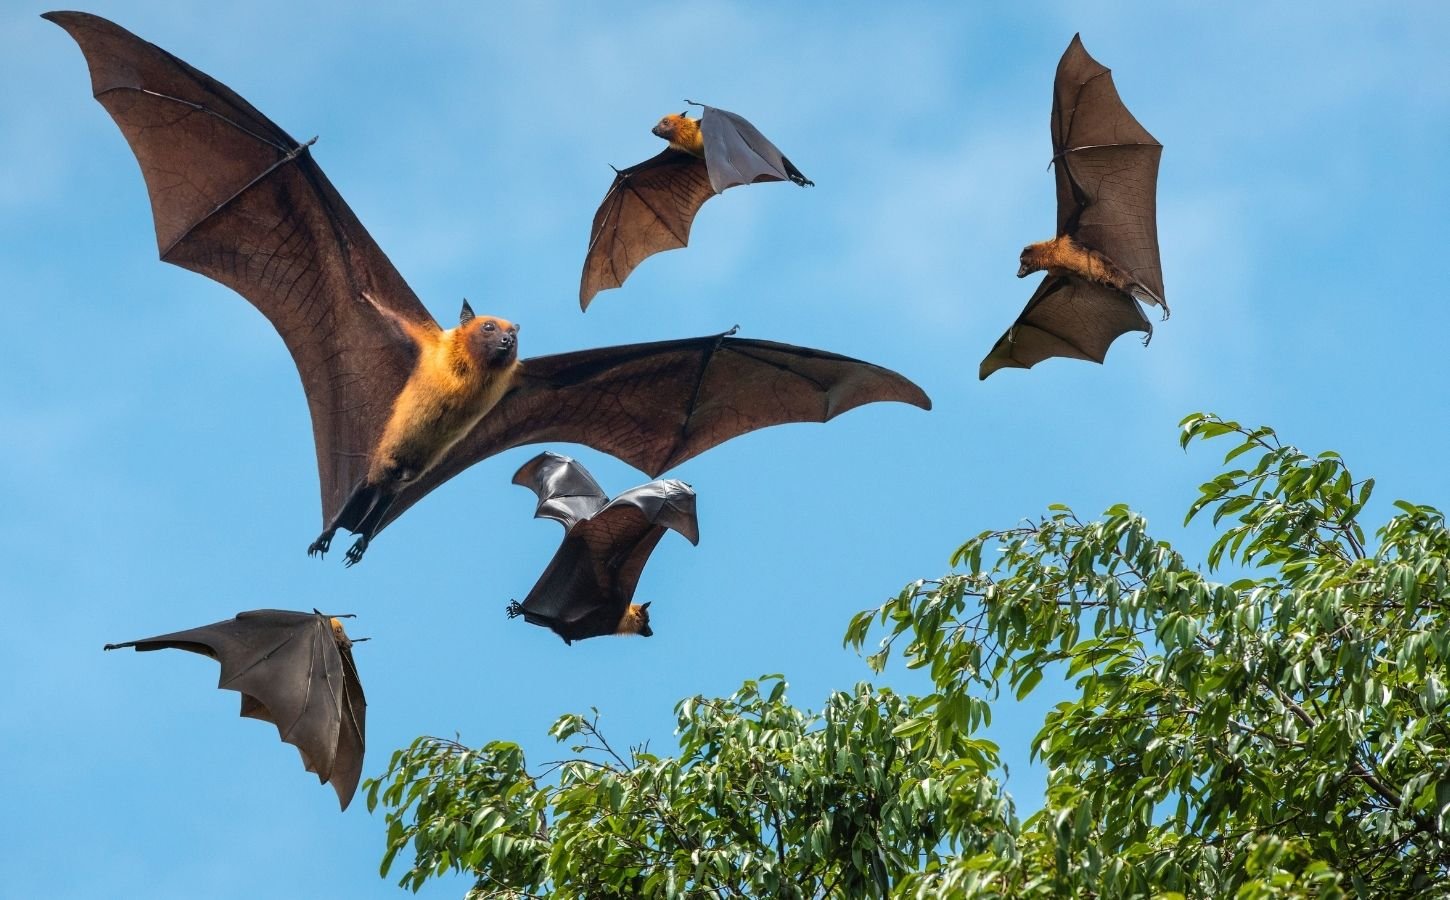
[579,149,715,309]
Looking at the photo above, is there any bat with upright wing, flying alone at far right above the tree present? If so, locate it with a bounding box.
[977,35,1169,378]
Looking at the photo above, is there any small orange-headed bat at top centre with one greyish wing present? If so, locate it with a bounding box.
[579,100,815,310]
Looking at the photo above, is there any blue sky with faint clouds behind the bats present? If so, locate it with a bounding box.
[0,0,1450,897]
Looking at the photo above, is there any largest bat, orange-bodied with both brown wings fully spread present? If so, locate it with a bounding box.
[45,13,931,565]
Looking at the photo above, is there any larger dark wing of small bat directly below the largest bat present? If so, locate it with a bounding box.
[521,480,699,641]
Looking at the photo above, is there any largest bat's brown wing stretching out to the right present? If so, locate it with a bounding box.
[386,335,931,522]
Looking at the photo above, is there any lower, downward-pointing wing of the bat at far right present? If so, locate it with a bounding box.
[977,275,1153,378]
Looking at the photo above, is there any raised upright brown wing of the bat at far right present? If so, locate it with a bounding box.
[1053,35,1167,309]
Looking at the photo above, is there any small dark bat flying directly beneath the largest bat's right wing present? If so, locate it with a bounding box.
[508,452,700,643]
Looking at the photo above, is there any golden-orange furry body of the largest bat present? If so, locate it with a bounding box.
[367,316,519,484]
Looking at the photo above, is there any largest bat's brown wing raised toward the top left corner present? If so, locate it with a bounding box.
[45,13,438,522]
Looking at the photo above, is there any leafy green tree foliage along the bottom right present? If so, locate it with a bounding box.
[368,414,1450,899]
